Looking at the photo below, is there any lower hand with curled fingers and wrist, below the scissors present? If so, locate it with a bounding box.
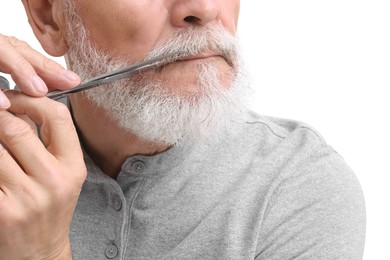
[0,90,86,260]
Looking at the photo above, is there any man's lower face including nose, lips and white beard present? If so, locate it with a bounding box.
[65,0,245,144]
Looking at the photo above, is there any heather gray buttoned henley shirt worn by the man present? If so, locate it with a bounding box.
[71,112,365,260]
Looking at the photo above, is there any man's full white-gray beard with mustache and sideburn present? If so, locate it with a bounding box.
[62,0,248,145]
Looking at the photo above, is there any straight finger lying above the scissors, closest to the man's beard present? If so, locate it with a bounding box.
[9,37,81,89]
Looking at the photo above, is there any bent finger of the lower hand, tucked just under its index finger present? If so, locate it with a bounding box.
[0,108,57,179]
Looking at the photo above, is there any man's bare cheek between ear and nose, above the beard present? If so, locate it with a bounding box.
[76,1,167,60]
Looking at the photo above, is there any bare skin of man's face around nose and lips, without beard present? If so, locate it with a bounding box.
[66,0,240,93]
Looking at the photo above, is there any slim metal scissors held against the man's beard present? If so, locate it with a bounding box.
[0,52,183,100]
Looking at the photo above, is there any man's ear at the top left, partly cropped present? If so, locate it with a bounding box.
[22,0,68,57]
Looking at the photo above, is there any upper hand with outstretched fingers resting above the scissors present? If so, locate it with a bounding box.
[0,34,80,109]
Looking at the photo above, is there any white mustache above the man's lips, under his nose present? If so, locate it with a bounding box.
[146,25,239,67]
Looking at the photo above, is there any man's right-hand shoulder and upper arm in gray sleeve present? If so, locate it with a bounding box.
[239,112,365,259]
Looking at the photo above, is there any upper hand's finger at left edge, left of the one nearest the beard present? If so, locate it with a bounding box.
[0,35,47,96]
